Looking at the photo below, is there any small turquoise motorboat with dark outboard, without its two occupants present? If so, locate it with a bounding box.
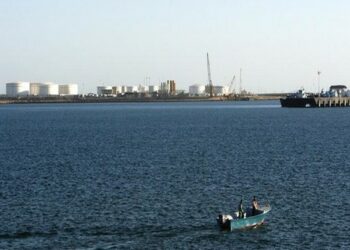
[217,204,271,231]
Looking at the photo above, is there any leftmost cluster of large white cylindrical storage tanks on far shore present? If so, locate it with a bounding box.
[6,82,78,97]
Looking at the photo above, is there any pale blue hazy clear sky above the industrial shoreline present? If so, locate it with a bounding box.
[0,0,350,93]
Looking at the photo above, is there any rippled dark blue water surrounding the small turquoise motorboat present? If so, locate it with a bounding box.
[0,102,350,249]
